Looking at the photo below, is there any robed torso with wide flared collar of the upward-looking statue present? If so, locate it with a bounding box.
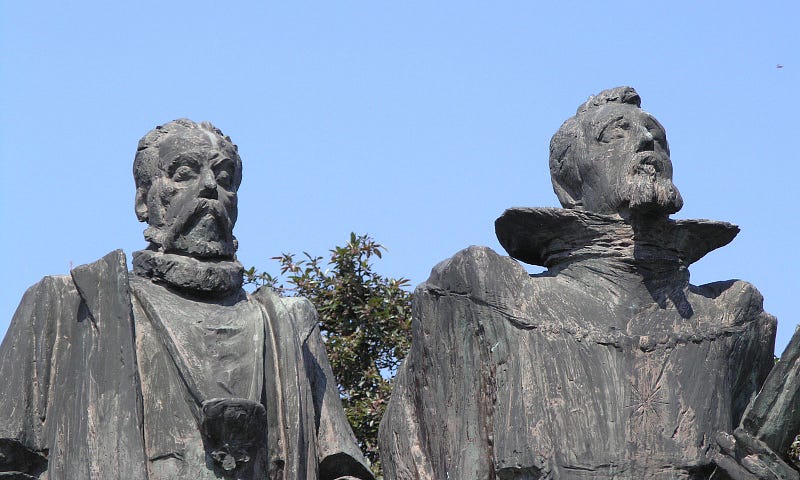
[380,209,775,480]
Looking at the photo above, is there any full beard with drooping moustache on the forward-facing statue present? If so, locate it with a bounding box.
[145,198,238,258]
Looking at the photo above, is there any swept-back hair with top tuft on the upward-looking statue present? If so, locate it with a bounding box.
[550,87,642,209]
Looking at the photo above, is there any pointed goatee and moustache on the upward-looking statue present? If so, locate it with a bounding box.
[617,152,683,214]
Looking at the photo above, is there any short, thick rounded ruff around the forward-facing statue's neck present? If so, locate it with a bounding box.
[133,250,244,298]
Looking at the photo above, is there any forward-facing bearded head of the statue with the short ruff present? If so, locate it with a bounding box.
[133,119,242,259]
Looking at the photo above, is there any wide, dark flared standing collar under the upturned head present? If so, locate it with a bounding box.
[495,207,739,271]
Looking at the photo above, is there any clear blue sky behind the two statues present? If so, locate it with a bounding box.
[0,0,800,351]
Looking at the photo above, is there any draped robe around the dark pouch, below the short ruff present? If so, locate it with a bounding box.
[0,251,372,479]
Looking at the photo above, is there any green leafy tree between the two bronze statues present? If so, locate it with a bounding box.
[245,233,411,474]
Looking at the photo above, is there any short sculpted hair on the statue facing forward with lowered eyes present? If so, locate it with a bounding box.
[133,118,242,201]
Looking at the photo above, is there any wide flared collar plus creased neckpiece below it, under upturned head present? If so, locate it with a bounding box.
[495,208,739,304]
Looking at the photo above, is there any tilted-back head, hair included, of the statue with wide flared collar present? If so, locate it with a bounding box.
[550,87,683,215]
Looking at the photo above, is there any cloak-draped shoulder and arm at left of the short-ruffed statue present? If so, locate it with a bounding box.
[0,250,146,478]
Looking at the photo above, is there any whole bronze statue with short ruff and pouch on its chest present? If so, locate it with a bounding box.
[0,119,373,480]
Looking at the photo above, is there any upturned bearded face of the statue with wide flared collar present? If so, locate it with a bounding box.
[578,104,683,214]
